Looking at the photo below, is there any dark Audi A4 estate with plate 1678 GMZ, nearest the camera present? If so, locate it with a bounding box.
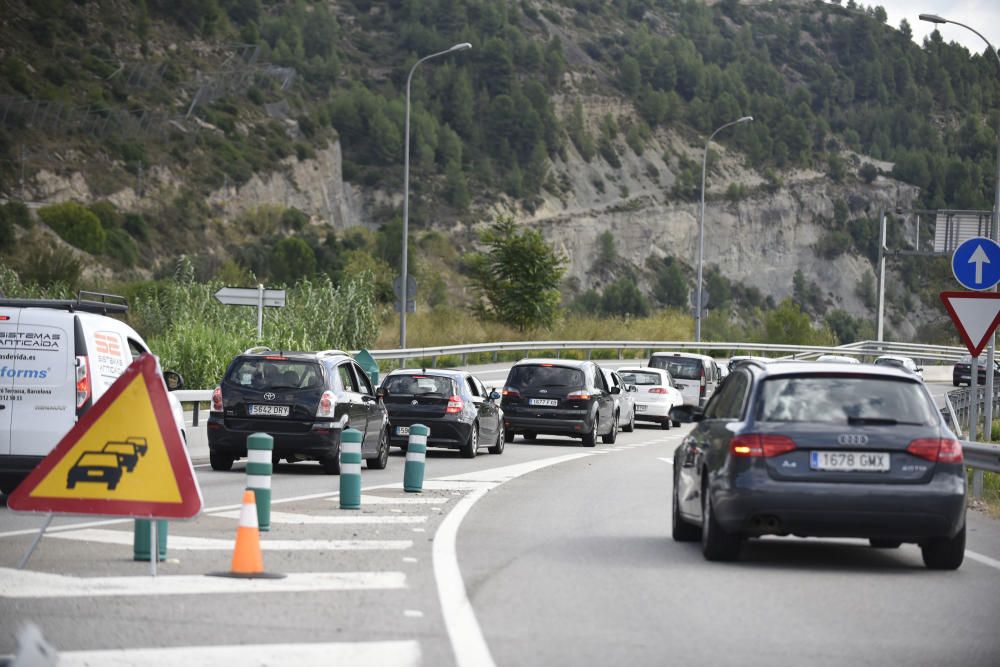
[671,362,966,569]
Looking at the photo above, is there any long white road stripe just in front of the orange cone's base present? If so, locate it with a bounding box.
[0,567,406,600]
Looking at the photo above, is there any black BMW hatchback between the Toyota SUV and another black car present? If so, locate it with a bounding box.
[377,368,504,459]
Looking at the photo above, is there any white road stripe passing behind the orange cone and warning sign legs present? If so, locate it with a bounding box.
[45,528,413,551]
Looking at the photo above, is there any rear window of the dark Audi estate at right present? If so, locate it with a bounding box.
[757,375,934,425]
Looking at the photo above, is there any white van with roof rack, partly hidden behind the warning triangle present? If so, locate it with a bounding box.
[0,292,187,493]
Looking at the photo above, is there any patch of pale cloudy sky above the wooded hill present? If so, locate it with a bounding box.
[842,0,1000,53]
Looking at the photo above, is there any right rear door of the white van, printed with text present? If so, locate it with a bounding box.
[5,309,76,456]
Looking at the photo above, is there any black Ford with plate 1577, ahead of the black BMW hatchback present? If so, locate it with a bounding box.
[500,359,619,447]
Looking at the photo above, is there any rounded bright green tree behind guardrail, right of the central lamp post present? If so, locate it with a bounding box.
[469,215,565,331]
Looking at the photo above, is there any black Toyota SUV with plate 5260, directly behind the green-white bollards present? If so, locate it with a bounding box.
[208,348,389,475]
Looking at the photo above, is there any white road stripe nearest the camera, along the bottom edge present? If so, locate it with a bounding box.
[59,640,421,667]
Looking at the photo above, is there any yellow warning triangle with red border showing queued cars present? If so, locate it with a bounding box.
[7,354,202,519]
